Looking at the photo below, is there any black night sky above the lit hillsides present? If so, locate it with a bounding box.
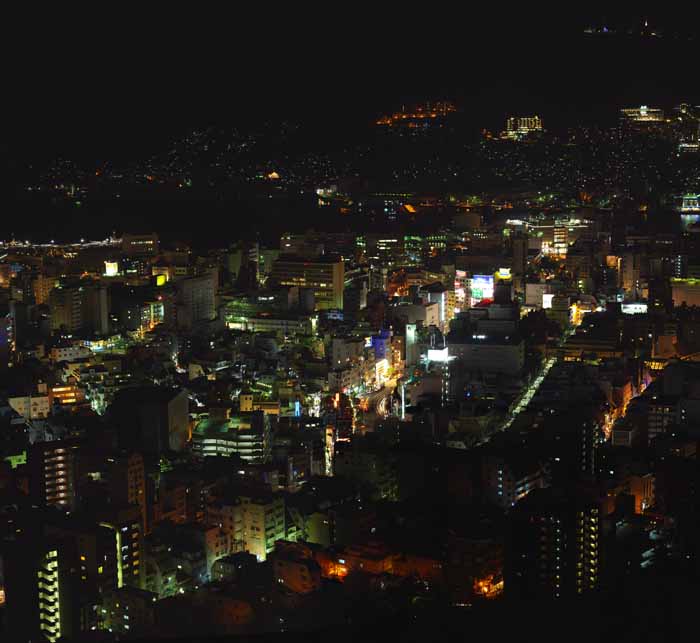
[5,10,700,162]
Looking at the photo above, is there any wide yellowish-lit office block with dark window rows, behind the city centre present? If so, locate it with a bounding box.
[270,255,345,310]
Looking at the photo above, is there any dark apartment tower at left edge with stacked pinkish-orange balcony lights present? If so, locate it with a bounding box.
[27,440,78,511]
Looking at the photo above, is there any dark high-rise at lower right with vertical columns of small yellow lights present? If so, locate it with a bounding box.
[504,487,608,599]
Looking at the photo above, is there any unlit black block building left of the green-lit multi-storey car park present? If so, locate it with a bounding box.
[109,386,189,456]
